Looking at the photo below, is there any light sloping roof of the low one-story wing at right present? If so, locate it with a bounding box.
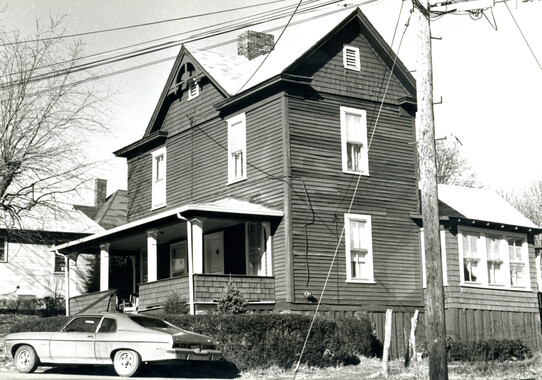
[438,185,540,229]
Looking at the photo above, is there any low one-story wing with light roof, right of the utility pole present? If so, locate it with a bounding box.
[428,185,541,347]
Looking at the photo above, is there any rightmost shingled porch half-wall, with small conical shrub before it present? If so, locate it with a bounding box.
[194,274,275,302]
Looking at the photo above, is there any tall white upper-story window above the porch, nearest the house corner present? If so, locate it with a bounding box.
[228,113,247,183]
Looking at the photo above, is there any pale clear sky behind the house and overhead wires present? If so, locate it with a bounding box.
[0,0,542,203]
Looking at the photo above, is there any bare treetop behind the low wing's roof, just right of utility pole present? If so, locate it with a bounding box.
[436,136,476,187]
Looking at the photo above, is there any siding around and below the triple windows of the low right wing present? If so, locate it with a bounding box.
[444,228,538,313]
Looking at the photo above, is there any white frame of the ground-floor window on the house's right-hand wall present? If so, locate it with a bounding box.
[344,214,374,283]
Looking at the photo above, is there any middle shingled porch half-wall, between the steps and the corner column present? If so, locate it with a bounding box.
[139,276,189,310]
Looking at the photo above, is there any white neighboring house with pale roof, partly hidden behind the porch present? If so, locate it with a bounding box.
[0,206,103,299]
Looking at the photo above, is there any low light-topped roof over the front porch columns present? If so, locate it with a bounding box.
[51,198,284,253]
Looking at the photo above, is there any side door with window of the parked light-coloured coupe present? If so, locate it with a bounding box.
[50,317,102,363]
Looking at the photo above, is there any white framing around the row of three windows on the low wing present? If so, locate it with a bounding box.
[457,227,531,291]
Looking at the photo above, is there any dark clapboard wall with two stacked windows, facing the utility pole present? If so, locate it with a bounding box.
[289,96,423,306]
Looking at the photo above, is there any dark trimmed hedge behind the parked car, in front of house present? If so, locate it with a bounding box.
[10,314,381,371]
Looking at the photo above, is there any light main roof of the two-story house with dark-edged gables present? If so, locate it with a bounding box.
[141,8,416,135]
